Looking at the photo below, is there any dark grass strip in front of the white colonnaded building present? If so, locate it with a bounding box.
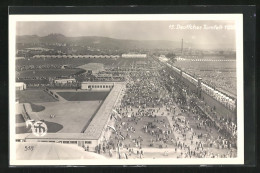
[57,92,109,101]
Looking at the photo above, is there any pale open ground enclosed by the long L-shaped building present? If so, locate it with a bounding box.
[37,101,101,133]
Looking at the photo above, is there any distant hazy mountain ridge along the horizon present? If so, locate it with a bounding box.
[16,34,193,49]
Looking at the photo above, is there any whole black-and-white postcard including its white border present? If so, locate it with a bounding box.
[9,14,244,165]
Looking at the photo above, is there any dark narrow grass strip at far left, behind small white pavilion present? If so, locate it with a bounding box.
[17,69,83,78]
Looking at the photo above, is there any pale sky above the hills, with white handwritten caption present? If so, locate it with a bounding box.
[16,20,236,48]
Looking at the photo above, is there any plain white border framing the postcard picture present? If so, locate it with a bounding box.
[9,14,244,165]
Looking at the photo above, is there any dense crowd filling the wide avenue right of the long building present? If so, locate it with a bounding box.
[102,60,237,158]
